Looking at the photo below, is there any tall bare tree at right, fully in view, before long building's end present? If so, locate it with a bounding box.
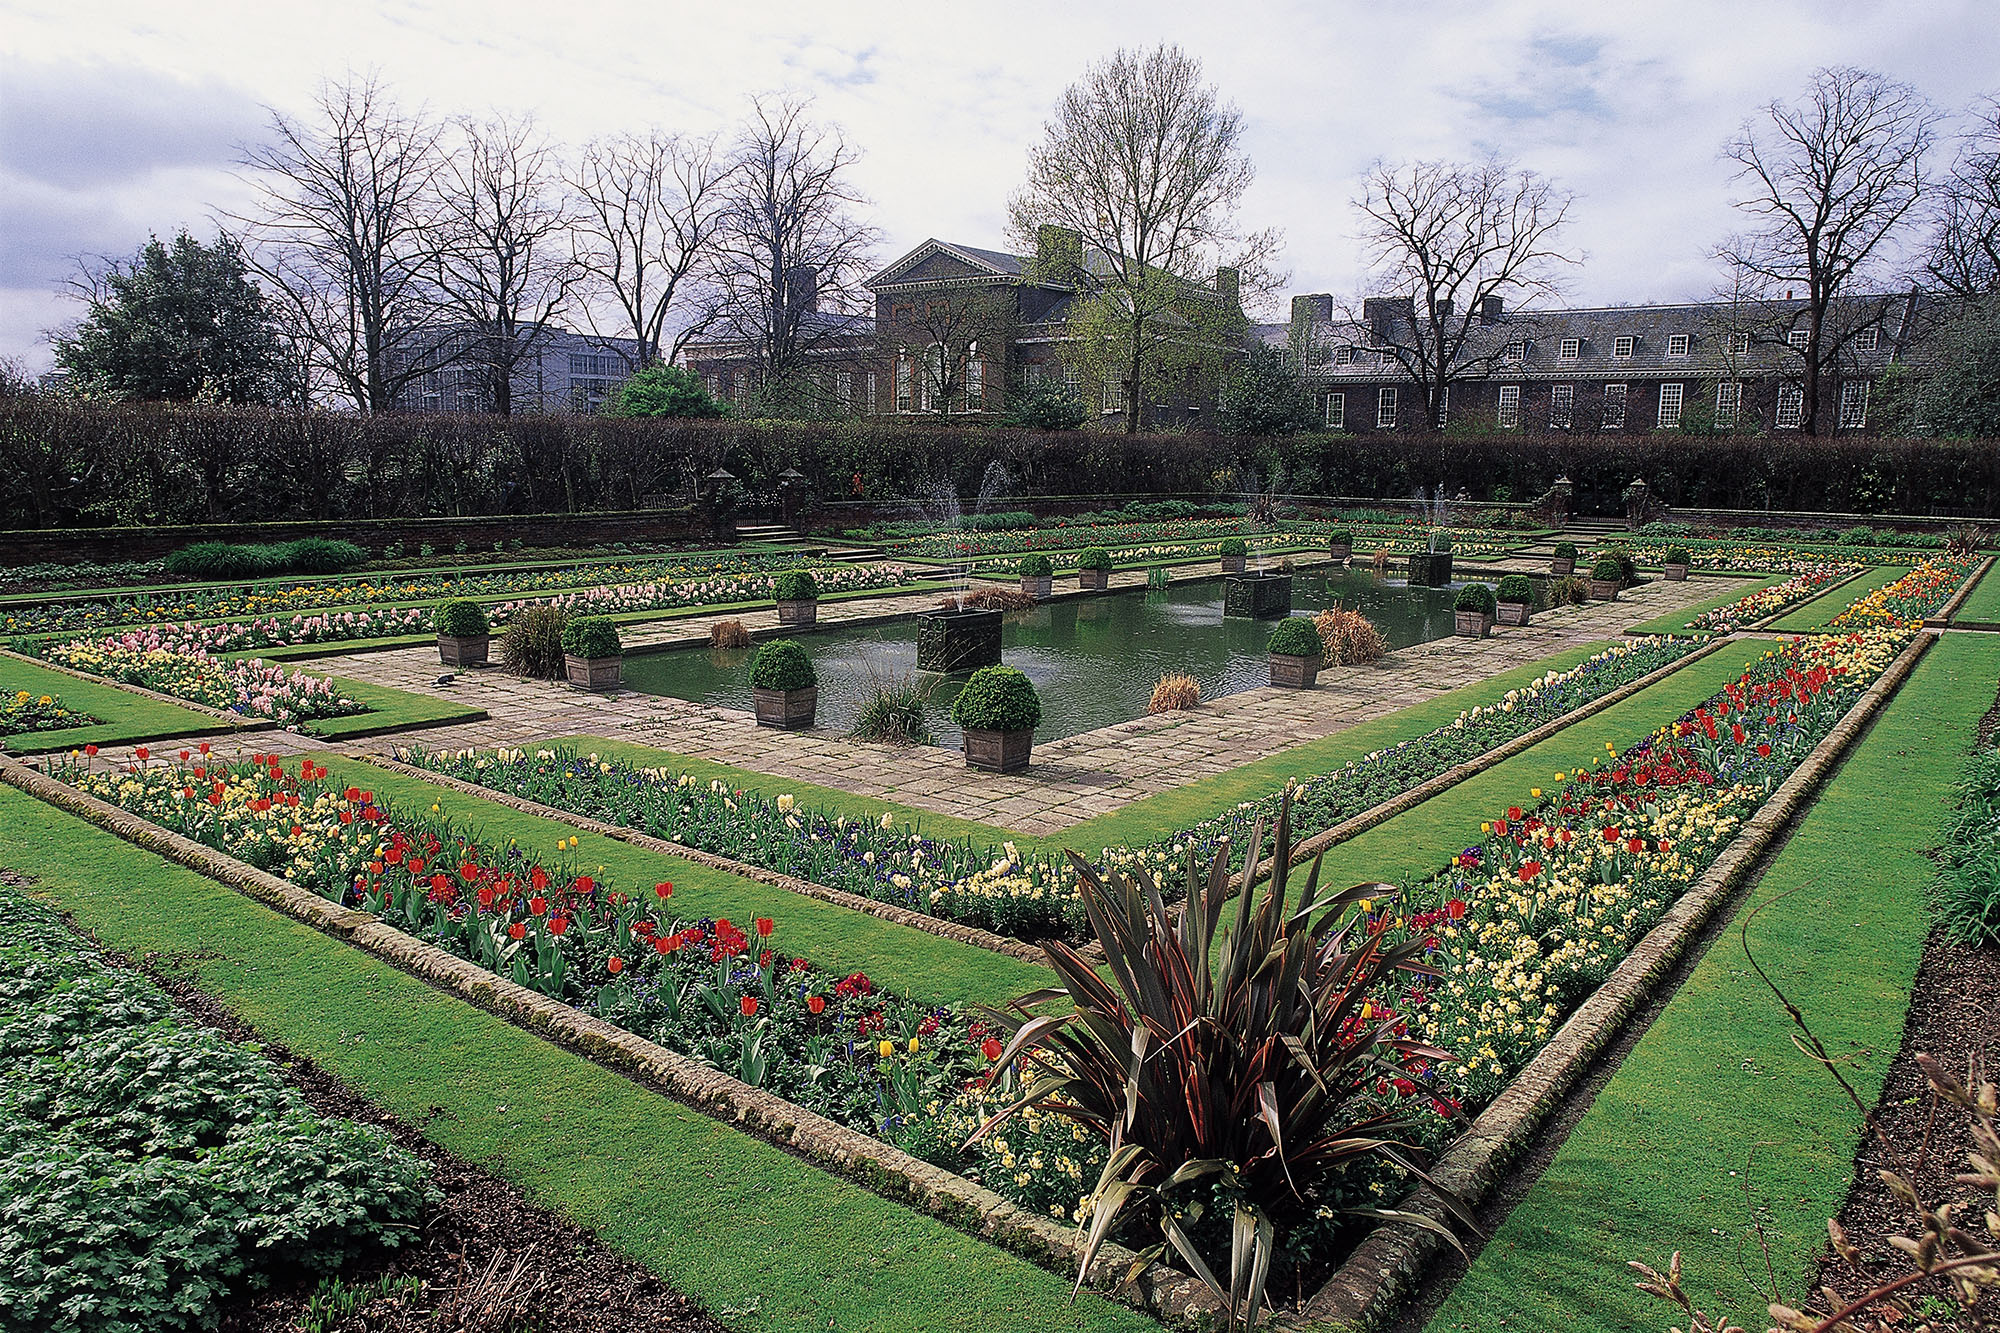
[1720,68,1938,434]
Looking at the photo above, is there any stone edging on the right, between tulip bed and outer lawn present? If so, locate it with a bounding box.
[1294,634,1936,1329]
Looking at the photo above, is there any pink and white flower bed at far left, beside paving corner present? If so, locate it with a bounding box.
[44,628,366,729]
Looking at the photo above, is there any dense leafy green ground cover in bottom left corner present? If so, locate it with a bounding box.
[0,881,424,1333]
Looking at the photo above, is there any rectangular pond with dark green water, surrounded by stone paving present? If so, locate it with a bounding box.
[624,570,1456,749]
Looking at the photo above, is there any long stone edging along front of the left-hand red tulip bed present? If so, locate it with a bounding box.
[0,755,1220,1321]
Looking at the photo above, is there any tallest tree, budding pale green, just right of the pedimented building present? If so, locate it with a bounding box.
[1008,46,1282,434]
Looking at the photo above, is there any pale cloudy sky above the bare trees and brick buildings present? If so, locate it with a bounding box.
[0,0,2000,370]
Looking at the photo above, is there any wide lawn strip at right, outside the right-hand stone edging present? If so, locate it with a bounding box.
[1430,634,2000,1333]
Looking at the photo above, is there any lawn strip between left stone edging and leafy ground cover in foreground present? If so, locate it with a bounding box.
[0,787,1158,1333]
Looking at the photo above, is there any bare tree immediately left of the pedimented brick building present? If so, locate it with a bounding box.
[714,96,876,396]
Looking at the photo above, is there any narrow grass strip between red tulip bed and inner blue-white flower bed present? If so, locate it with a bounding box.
[308,759,1052,1007]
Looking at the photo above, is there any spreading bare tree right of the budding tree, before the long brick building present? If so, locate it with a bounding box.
[1348,158,1582,430]
